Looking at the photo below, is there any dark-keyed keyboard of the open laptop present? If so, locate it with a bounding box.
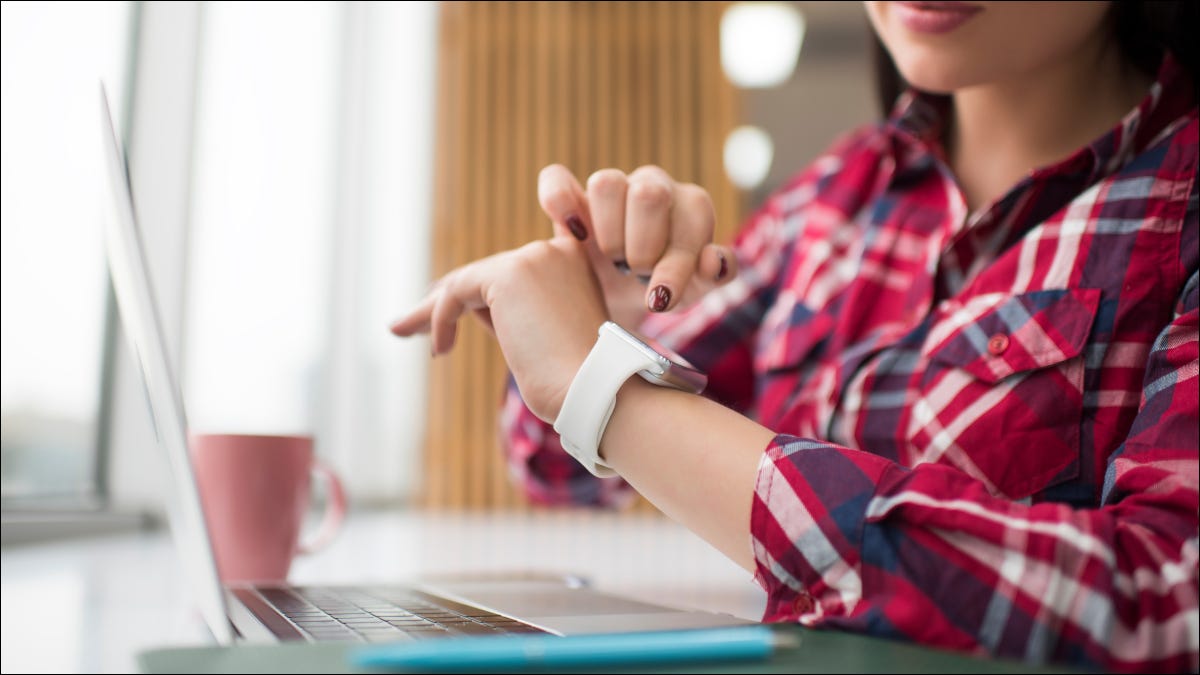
[258,587,545,643]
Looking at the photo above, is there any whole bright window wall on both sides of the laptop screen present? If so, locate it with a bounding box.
[0,2,437,510]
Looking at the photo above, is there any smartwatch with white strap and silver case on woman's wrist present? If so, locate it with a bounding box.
[554,321,708,478]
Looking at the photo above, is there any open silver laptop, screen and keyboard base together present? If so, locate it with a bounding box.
[101,84,752,645]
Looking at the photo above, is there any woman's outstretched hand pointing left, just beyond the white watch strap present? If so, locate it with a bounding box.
[391,237,608,422]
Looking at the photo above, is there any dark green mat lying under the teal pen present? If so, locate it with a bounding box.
[138,626,1080,674]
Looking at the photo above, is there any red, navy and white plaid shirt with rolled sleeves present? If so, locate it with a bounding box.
[502,58,1200,670]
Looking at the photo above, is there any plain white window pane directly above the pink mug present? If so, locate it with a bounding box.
[184,2,342,434]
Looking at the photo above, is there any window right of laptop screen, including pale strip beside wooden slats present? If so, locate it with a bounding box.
[182,2,437,503]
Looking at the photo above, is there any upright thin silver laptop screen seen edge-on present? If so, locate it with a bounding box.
[100,83,234,644]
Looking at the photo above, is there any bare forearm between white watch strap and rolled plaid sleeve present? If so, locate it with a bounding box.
[600,377,774,572]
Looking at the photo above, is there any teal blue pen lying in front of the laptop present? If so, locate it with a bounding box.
[350,626,786,673]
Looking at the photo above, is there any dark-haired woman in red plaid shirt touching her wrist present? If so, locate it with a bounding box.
[392,2,1200,670]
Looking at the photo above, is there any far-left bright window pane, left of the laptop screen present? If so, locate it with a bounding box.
[0,2,131,507]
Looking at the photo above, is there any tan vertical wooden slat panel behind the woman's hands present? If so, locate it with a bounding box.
[422,1,739,508]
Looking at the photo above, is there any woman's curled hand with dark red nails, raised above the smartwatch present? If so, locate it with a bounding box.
[538,159,737,328]
